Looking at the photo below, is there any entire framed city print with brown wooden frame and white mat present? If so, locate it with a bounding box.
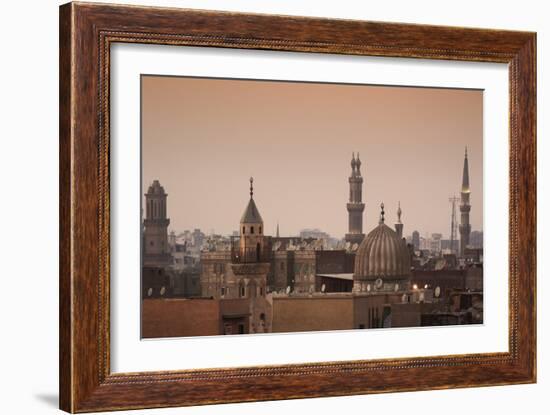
[60,3,536,412]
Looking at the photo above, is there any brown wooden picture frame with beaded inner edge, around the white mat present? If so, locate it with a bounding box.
[59,3,536,412]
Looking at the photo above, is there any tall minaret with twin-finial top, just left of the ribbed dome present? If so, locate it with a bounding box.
[346,153,365,244]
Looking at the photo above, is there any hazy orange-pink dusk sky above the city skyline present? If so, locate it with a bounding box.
[142,76,483,238]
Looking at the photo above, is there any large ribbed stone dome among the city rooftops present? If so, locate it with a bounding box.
[353,223,411,280]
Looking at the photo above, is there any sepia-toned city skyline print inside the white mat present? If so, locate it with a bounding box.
[141,75,483,338]
